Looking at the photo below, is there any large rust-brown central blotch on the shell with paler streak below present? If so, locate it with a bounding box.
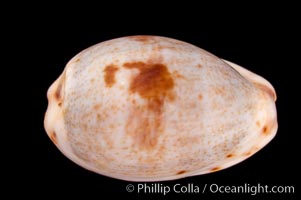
[123,62,174,149]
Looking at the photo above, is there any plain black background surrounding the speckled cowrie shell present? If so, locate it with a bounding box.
[7,8,300,199]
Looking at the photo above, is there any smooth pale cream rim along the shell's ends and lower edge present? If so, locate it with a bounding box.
[44,36,277,181]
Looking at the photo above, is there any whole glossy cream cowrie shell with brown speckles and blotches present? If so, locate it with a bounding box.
[45,36,277,181]
